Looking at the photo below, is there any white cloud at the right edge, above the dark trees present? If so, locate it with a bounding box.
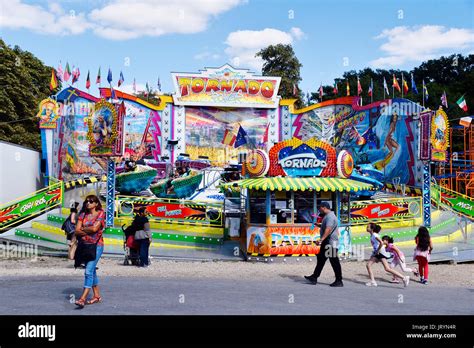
[370,25,474,68]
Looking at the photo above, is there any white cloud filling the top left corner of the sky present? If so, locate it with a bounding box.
[0,0,93,35]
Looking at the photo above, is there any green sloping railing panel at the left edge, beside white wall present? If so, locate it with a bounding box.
[0,181,64,231]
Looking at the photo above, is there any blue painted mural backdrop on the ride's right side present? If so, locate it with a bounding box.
[292,97,421,186]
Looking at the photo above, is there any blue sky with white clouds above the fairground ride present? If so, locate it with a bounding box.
[0,0,474,94]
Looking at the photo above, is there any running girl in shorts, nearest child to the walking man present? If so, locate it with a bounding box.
[365,222,410,286]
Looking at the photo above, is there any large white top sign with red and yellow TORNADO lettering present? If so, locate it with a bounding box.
[172,64,281,108]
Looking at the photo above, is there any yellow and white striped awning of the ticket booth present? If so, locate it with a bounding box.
[224,177,372,192]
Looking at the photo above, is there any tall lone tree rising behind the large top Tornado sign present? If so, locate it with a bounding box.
[256,44,304,107]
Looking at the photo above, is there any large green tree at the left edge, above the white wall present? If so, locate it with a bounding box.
[0,39,60,150]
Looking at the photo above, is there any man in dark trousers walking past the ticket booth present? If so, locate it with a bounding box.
[304,202,344,287]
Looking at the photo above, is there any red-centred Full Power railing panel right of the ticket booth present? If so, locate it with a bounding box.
[350,197,422,225]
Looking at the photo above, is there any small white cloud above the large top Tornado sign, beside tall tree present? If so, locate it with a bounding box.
[225,28,304,71]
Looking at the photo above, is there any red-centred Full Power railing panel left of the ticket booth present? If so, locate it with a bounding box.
[115,195,224,227]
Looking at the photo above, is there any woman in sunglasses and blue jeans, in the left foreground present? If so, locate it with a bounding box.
[75,195,105,308]
